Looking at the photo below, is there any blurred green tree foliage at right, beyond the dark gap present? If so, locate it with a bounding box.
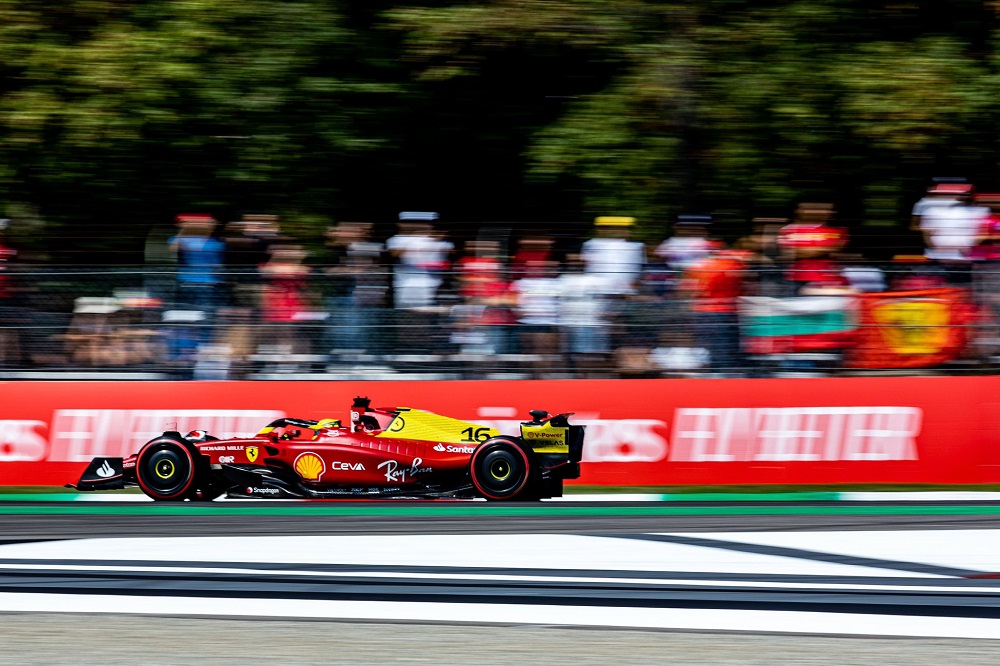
[392,0,1000,237]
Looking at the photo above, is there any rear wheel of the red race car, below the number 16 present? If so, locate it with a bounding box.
[469,437,534,501]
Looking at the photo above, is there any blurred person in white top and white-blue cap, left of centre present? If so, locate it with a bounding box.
[386,212,455,308]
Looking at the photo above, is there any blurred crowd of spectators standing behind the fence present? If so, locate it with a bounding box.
[0,181,1000,379]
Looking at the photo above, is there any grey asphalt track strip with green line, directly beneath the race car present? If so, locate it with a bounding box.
[0,500,1000,543]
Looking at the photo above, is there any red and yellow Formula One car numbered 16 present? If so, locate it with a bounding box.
[69,398,584,501]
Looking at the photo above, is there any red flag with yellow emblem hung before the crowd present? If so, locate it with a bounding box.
[847,288,973,369]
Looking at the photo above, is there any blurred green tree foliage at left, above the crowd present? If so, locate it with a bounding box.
[0,0,395,258]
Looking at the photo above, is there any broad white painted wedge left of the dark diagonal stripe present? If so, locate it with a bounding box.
[0,531,944,578]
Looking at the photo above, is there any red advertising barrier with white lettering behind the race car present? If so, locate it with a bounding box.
[0,377,1000,486]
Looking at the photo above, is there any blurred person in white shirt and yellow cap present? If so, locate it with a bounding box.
[580,216,646,295]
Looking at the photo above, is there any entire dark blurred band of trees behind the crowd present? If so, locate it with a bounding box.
[0,0,1000,264]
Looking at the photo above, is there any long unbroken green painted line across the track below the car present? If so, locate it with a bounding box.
[0,502,1000,518]
